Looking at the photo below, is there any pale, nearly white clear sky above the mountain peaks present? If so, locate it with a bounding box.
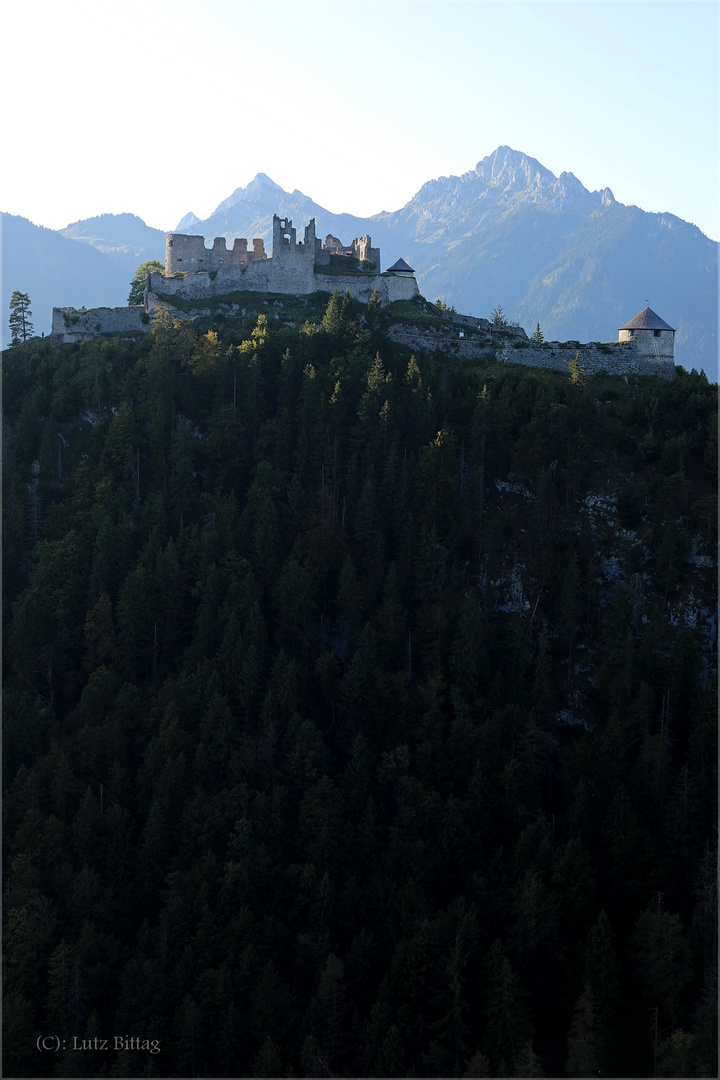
[0,0,720,240]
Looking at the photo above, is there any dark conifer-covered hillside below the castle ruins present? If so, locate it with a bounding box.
[3,294,718,1077]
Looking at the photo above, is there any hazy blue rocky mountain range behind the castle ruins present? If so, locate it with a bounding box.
[2,147,718,381]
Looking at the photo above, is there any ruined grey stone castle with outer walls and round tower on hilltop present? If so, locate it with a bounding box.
[51,214,675,379]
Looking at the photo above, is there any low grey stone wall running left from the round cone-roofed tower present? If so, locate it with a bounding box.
[500,341,675,379]
